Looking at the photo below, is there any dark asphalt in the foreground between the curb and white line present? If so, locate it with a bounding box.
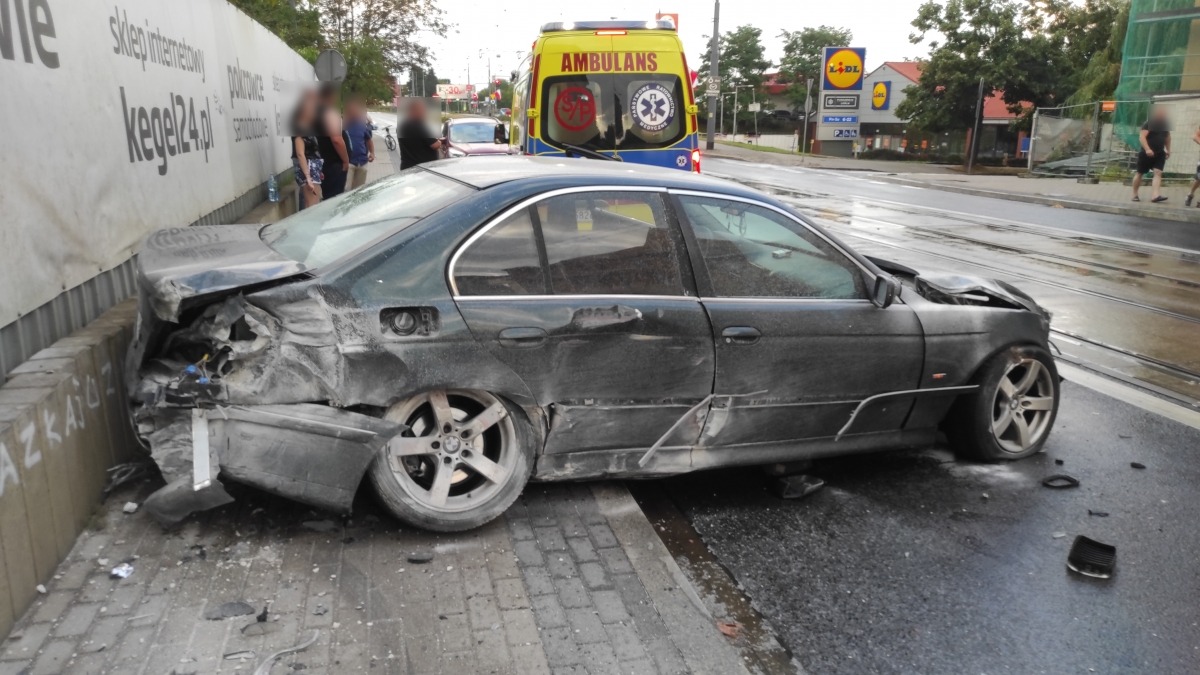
[666,383,1200,675]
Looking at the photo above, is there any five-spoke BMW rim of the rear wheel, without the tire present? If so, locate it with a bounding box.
[386,392,514,510]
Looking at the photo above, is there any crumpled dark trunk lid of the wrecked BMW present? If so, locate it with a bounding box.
[138,225,307,322]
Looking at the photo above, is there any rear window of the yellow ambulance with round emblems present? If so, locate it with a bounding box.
[541,73,686,150]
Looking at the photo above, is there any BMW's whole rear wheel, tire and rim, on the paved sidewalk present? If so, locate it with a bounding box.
[368,390,534,532]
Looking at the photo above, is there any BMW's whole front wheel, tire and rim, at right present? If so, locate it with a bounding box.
[946,347,1060,461]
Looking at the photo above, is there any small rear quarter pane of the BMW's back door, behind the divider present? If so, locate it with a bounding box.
[454,209,546,295]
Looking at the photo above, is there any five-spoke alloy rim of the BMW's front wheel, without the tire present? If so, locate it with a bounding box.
[991,359,1056,453]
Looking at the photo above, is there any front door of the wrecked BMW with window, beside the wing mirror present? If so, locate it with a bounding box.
[676,193,924,444]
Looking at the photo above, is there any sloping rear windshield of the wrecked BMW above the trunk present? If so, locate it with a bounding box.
[258,169,470,268]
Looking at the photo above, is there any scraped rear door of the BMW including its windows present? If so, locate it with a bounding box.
[450,189,715,453]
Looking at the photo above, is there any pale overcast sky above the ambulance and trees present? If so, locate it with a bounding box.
[424,0,928,85]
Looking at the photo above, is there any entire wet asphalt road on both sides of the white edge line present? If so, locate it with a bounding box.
[664,159,1200,675]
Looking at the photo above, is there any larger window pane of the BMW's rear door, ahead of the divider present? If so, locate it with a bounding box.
[535,192,686,295]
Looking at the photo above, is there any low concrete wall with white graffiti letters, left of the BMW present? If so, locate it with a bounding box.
[0,300,137,635]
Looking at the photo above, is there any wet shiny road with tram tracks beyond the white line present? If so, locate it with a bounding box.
[708,160,1200,407]
